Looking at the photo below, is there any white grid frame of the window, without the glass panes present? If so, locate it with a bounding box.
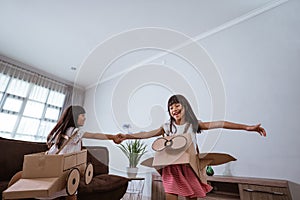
[0,60,70,142]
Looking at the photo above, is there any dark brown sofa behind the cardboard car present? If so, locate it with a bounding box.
[0,137,128,200]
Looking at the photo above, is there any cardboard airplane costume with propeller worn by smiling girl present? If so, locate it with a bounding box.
[141,133,236,183]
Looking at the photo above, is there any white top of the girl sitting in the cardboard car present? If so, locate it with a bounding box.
[48,127,85,154]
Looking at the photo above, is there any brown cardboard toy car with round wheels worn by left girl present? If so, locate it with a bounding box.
[2,150,93,199]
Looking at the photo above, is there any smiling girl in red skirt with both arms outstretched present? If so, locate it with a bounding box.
[118,95,266,200]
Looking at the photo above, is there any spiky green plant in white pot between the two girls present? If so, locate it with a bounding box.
[118,139,147,177]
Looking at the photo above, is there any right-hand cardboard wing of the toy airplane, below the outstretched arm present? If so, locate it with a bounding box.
[199,153,236,166]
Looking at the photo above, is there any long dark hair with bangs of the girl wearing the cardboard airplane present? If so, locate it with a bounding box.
[168,94,201,133]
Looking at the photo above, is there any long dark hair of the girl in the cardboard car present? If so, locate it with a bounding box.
[47,106,85,148]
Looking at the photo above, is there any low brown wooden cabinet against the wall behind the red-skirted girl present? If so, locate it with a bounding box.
[151,174,300,200]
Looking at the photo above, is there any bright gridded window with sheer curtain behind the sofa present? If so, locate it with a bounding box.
[0,61,67,142]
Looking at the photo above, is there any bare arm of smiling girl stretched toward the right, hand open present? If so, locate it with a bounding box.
[199,121,267,136]
